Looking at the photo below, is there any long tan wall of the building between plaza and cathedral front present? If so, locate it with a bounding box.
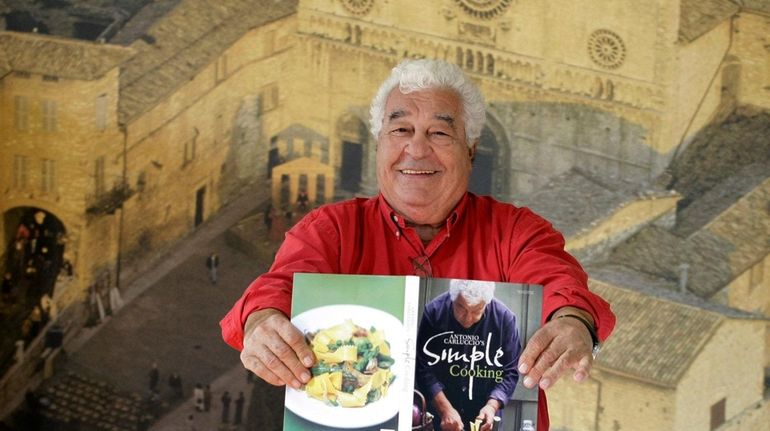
[123,20,292,268]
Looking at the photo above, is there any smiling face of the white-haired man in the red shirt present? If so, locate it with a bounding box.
[377,88,475,224]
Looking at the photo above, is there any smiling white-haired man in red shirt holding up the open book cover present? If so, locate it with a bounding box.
[220,60,615,429]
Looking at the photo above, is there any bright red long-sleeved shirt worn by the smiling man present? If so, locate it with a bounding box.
[220,193,615,429]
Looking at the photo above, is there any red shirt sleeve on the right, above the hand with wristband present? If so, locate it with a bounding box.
[508,208,615,340]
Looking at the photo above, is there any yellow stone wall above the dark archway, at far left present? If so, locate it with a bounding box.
[0,59,123,318]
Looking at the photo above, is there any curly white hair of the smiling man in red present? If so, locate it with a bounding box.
[369,59,486,147]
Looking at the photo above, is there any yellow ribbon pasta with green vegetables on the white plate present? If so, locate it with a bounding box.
[305,319,395,407]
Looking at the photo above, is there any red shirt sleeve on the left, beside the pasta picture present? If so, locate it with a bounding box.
[219,210,339,351]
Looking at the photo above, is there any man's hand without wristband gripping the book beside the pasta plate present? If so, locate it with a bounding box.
[241,308,314,389]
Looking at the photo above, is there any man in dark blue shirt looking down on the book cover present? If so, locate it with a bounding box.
[416,279,521,430]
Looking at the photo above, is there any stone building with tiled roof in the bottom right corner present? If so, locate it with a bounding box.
[549,278,770,430]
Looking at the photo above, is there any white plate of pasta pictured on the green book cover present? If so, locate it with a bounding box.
[285,304,404,430]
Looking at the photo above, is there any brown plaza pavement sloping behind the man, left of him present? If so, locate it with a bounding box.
[61,186,283,431]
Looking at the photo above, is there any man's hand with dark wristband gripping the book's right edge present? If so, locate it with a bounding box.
[519,307,593,390]
